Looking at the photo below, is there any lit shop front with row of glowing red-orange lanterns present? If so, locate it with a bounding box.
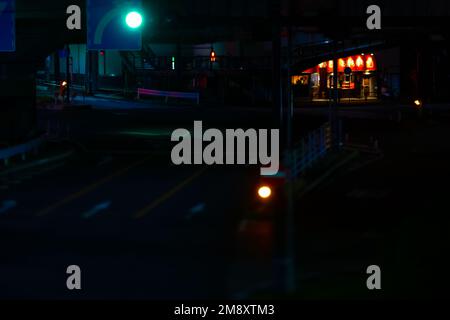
[292,54,378,100]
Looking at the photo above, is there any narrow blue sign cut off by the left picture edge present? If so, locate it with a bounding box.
[0,0,16,52]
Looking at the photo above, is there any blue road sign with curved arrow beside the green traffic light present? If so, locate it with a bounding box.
[88,0,142,51]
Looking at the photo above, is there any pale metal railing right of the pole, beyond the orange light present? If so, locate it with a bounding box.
[290,123,333,177]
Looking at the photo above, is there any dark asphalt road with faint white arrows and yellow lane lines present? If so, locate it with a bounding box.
[0,103,268,299]
